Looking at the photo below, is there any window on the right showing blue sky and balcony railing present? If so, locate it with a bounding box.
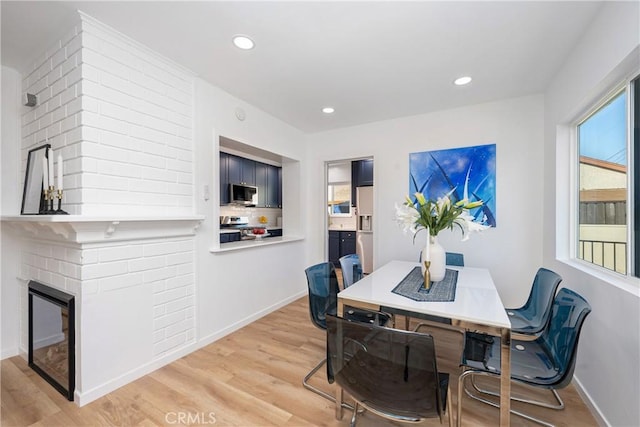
[576,78,640,275]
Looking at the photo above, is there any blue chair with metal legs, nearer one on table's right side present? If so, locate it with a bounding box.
[457,288,591,426]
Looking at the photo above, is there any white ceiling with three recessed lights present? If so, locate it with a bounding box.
[1,0,602,133]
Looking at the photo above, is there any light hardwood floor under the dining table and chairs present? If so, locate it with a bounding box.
[0,298,597,427]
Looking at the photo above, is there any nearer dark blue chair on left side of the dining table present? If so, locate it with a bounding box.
[302,262,390,402]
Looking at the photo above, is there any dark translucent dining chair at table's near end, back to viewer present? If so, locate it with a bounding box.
[327,315,453,427]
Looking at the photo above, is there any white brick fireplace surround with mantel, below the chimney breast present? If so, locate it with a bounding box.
[4,215,200,405]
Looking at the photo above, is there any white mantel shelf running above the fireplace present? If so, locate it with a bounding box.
[0,215,204,243]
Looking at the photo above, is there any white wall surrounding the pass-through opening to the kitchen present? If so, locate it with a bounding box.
[195,79,308,345]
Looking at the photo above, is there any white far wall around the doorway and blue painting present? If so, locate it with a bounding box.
[306,96,543,306]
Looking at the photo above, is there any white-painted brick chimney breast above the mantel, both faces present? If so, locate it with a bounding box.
[22,14,193,216]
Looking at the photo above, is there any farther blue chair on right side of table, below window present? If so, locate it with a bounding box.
[506,268,562,338]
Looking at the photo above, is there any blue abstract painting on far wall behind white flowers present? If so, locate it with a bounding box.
[409,144,496,227]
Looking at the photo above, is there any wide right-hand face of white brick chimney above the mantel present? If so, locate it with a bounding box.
[77,15,194,215]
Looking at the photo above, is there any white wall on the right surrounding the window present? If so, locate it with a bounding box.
[542,2,640,426]
